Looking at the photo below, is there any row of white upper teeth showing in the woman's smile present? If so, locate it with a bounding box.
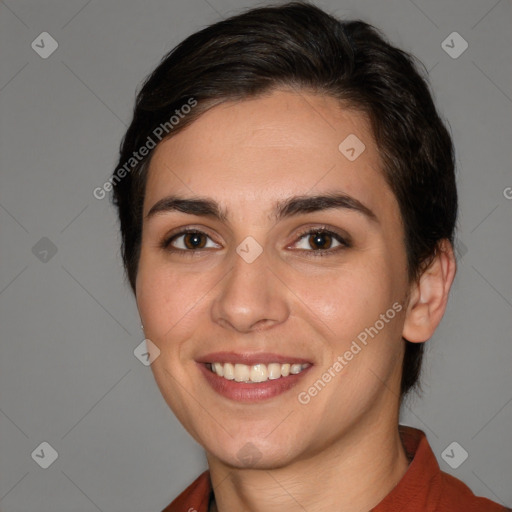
[210,362,310,382]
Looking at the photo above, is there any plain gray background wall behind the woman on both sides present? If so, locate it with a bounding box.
[0,0,512,512]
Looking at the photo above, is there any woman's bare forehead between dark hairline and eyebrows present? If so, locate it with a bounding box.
[144,91,394,220]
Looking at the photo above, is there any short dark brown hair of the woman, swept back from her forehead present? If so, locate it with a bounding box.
[113,2,457,396]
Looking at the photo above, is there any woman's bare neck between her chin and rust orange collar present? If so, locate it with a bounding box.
[208,421,408,512]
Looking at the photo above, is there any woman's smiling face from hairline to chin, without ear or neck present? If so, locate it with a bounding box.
[136,90,408,467]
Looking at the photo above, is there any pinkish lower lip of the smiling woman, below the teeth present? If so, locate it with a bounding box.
[197,363,312,402]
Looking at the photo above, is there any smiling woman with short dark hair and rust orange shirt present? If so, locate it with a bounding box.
[112,3,504,512]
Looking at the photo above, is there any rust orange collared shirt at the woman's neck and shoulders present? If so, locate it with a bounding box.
[162,426,511,512]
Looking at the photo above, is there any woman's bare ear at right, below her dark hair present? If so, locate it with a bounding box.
[402,239,457,343]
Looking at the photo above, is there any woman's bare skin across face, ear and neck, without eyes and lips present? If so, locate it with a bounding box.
[136,90,455,512]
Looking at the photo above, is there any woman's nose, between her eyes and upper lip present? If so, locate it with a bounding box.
[212,246,290,333]
